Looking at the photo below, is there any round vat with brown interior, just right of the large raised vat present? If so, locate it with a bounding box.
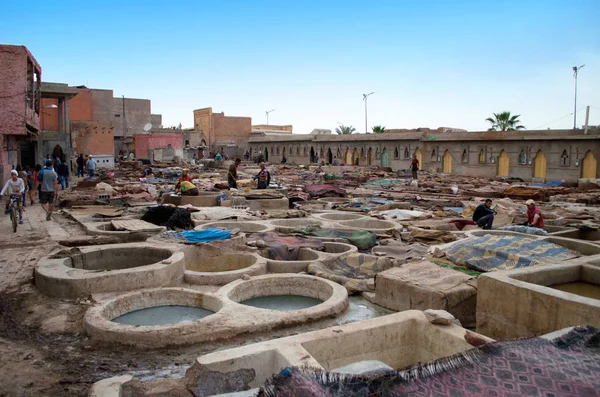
[184,248,267,285]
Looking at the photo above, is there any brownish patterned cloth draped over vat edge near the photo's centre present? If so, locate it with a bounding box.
[308,253,393,293]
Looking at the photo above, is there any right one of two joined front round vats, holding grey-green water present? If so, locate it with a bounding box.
[224,274,348,312]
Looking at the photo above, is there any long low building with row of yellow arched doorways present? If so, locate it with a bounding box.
[248,129,600,182]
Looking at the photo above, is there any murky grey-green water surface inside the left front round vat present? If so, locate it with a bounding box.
[111,305,214,327]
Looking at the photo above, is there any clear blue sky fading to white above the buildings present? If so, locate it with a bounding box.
[0,0,600,133]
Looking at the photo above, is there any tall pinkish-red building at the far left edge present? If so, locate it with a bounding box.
[0,45,42,184]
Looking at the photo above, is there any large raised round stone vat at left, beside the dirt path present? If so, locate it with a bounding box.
[35,243,185,298]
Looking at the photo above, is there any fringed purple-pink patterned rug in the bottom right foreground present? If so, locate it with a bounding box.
[258,326,600,397]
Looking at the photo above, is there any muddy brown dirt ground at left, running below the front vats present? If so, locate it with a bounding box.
[0,204,390,397]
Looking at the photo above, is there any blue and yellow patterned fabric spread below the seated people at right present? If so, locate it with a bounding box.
[446,235,579,272]
